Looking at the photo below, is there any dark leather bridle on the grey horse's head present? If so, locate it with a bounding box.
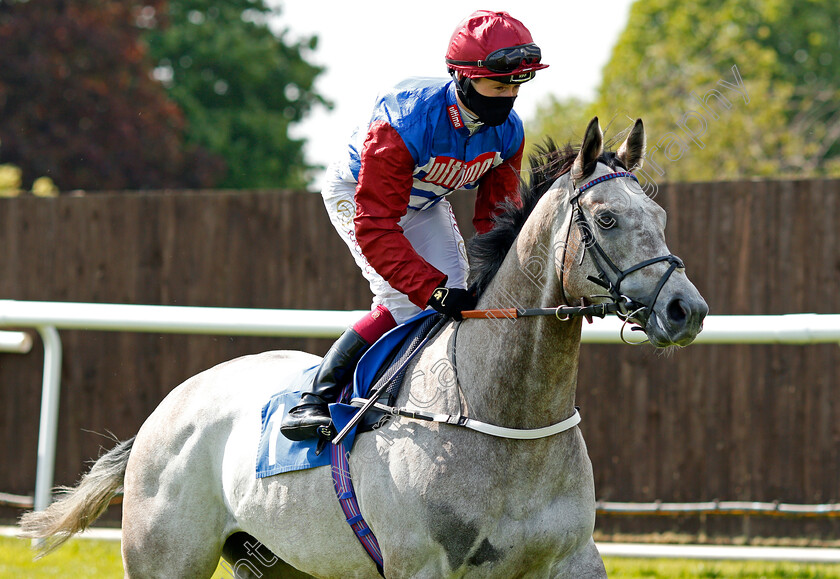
[560,171,685,329]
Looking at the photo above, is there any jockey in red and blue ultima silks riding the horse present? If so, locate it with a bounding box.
[280,10,548,440]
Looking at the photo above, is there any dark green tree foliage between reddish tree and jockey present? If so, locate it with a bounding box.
[146,0,329,188]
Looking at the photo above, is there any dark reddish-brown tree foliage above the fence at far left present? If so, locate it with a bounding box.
[0,0,223,190]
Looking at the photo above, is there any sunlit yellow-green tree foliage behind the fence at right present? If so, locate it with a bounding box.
[536,0,840,180]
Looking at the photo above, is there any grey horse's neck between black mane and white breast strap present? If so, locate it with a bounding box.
[456,188,581,428]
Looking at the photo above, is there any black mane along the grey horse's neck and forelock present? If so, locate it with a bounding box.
[467,138,626,296]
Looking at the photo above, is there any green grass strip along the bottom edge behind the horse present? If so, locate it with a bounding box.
[0,537,840,579]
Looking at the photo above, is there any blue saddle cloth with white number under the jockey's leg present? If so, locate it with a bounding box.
[257,311,438,478]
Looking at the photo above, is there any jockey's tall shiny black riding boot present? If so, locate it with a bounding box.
[280,328,370,440]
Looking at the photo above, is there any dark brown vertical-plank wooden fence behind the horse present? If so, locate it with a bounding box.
[0,180,840,536]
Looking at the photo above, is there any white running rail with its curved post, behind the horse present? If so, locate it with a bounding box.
[0,300,840,510]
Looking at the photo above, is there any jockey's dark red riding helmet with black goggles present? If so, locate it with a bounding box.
[446,10,548,83]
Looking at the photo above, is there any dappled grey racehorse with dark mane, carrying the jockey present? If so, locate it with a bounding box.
[21,118,708,579]
